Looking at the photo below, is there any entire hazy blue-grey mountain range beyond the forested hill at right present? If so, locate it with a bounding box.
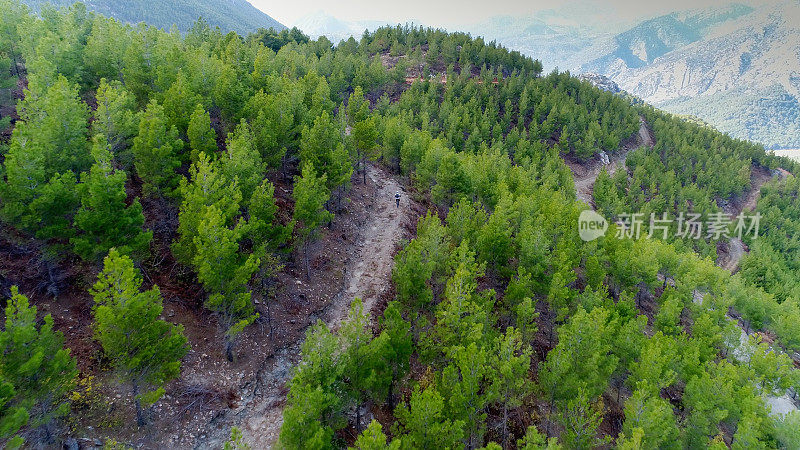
[470,0,800,148]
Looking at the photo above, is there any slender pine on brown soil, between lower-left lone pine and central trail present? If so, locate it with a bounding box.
[192,205,259,361]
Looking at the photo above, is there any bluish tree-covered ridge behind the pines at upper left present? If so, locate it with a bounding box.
[23,0,286,35]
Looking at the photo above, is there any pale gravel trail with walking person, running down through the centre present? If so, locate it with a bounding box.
[234,165,420,448]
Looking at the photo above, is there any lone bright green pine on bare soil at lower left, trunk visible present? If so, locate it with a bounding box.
[90,248,189,426]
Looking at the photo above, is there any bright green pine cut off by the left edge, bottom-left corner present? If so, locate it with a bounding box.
[0,286,78,445]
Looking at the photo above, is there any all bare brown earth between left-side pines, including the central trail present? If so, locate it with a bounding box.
[0,166,424,448]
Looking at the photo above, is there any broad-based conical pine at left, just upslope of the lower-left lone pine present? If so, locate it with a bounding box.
[70,135,153,261]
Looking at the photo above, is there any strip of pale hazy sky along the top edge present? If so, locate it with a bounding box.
[248,0,776,28]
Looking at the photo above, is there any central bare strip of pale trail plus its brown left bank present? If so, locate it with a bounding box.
[187,165,423,448]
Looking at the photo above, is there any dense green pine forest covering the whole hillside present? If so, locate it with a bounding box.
[0,0,800,450]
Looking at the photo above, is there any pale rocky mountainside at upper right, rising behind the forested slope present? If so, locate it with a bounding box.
[581,2,800,148]
